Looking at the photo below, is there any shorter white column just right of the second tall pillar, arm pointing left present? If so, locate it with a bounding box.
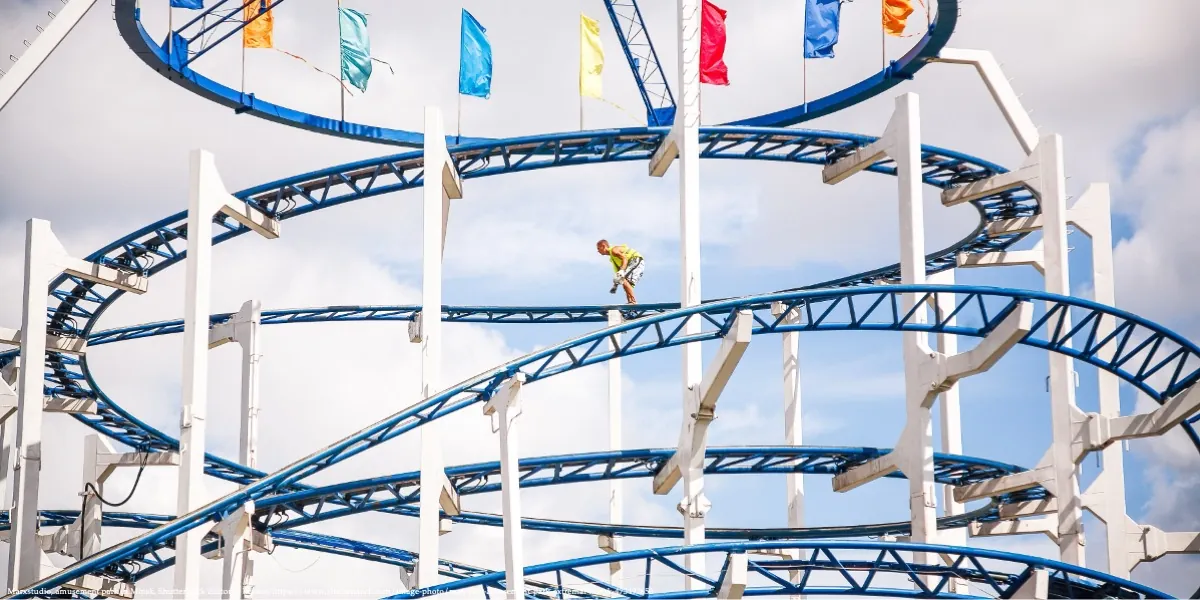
[209,300,263,600]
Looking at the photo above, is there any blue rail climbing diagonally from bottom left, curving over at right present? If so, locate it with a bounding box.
[18,286,1200,596]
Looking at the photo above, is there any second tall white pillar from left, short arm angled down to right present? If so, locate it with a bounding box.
[174,150,280,600]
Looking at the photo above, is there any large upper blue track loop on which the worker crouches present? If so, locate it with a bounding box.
[0,127,1038,484]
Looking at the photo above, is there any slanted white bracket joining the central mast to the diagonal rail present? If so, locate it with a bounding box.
[653,311,754,494]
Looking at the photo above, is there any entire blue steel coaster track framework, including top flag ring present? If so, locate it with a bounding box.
[0,0,1200,598]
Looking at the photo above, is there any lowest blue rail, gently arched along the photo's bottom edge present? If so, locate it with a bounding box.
[398,541,1170,599]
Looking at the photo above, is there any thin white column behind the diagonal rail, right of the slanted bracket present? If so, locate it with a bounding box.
[770,302,804,599]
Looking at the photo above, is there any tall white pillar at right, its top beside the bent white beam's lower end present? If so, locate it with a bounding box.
[1036,134,1084,566]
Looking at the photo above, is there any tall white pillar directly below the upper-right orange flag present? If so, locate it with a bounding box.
[889,94,937,563]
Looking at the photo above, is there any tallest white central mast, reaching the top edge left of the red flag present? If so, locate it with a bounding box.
[673,0,708,589]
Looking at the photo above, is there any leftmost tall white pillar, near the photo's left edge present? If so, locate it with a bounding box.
[8,218,60,589]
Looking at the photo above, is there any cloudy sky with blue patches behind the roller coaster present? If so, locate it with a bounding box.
[0,0,1200,595]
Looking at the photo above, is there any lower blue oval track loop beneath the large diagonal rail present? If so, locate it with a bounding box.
[7,446,1012,583]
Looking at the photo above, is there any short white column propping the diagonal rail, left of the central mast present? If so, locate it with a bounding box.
[484,373,526,600]
